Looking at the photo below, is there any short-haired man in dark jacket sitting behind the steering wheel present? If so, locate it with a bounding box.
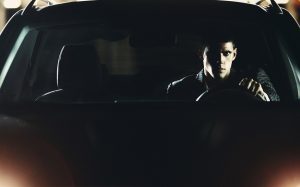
[167,35,279,101]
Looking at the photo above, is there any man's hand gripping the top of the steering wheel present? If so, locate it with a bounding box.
[239,78,270,101]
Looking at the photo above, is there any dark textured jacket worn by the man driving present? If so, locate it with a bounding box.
[167,69,280,101]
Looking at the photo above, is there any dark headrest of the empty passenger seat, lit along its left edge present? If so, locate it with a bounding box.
[57,44,103,90]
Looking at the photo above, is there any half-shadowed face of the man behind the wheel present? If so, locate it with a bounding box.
[203,41,237,80]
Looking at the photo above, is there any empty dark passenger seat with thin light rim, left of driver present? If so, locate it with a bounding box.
[36,44,107,102]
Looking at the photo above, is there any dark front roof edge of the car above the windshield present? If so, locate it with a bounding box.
[23,0,269,24]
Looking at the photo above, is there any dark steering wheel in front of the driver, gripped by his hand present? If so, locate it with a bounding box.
[196,87,263,103]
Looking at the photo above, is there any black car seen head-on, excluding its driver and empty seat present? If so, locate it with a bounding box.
[0,1,300,186]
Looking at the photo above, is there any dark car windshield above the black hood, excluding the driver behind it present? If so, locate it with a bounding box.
[2,21,280,103]
